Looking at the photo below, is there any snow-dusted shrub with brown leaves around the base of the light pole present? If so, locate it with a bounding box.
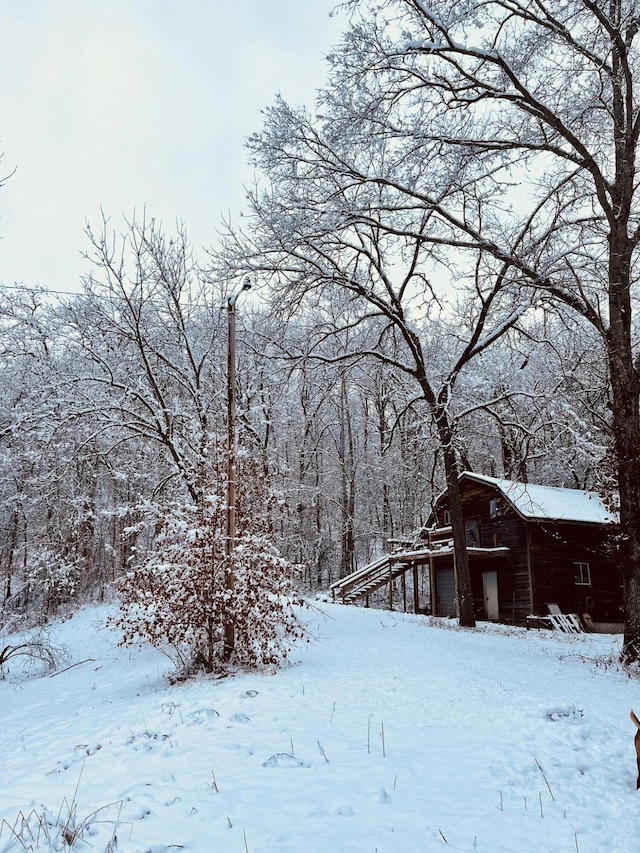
[113,456,304,672]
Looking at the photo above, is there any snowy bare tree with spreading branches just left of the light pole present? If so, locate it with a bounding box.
[63,213,223,503]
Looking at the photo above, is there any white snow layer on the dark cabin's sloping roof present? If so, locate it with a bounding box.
[462,471,618,524]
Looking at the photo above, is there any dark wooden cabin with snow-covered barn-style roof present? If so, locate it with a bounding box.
[428,472,623,625]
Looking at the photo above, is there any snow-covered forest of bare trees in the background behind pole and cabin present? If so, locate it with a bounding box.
[0,215,610,620]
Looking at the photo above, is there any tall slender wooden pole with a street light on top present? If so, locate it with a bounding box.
[223,277,251,660]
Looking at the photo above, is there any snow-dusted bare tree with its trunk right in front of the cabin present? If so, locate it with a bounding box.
[220,87,527,626]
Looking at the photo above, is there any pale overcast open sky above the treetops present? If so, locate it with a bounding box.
[0,0,344,290]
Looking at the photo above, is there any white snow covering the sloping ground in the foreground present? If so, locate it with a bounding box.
[0,604,640,853]
